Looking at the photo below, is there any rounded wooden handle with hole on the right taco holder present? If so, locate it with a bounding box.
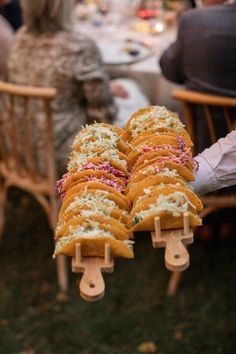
[165,236,189,271]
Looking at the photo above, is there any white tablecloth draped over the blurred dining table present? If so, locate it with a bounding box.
[75,15,183,110]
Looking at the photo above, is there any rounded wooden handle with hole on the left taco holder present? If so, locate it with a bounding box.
[79,258,105,301]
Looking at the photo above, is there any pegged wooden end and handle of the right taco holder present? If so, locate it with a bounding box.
[151,213,193,272]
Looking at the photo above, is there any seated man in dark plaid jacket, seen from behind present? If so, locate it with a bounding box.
[160,0,236,152]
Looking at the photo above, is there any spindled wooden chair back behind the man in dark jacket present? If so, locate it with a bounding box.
[172,89,236,153]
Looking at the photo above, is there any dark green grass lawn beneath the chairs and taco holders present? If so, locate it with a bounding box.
[0,192,236,354]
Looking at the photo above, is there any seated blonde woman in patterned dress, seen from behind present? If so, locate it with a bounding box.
[8,0,149,171]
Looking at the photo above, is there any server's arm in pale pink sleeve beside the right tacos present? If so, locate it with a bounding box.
[189,130,236,194]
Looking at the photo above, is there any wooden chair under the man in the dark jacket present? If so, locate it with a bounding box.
[167,89,236,295]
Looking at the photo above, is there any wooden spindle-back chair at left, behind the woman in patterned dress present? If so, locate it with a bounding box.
[0,82,68,291]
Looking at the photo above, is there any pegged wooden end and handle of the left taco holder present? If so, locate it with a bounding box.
[72,243,114,301]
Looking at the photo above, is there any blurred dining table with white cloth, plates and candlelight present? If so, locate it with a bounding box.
[74,7,183,111]
